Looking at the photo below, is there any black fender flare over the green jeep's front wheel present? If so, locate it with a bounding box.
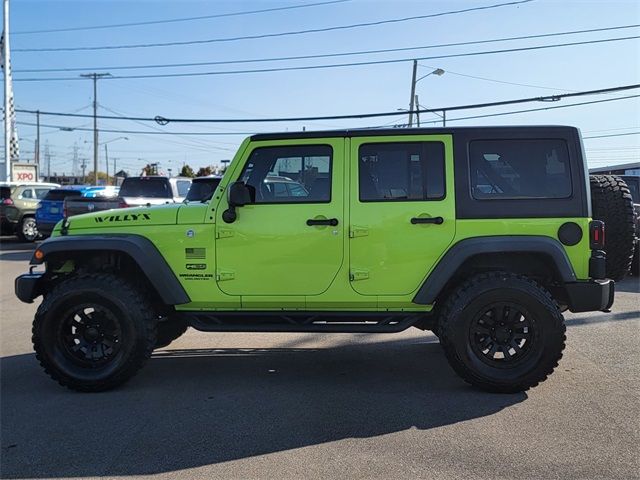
[30,234,191,305]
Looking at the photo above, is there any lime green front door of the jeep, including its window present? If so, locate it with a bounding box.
[216,139,344,296]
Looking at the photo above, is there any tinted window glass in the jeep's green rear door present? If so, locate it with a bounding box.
[358,142,445,202]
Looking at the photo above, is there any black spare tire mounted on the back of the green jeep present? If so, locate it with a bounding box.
[589,175,635,281]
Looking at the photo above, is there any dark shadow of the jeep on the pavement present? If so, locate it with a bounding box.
[1,337,527,478]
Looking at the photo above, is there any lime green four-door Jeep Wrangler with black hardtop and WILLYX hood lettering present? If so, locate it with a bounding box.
[15,127,633,392]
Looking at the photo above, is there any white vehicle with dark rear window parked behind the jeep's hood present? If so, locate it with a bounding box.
[119,176,191,207]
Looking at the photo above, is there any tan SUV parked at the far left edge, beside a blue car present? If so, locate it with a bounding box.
[0,182,60,242]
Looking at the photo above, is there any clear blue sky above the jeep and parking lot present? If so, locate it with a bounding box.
[6,0,640,174]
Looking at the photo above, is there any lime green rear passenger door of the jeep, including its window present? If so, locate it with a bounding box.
[349,135,455,296]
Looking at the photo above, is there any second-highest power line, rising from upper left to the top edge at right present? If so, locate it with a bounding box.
[13,0,533,52]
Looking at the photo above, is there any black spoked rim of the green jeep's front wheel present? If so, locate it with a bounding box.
[58,303,122,367]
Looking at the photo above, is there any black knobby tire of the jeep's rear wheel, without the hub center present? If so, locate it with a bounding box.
[438,272,566,393]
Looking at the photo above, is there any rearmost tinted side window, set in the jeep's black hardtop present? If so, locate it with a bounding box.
[469,139,572,200]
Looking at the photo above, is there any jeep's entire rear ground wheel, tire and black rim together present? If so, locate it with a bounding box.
[439,272,566,393]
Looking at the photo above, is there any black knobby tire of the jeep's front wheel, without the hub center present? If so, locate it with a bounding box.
[32,273,158,392]
